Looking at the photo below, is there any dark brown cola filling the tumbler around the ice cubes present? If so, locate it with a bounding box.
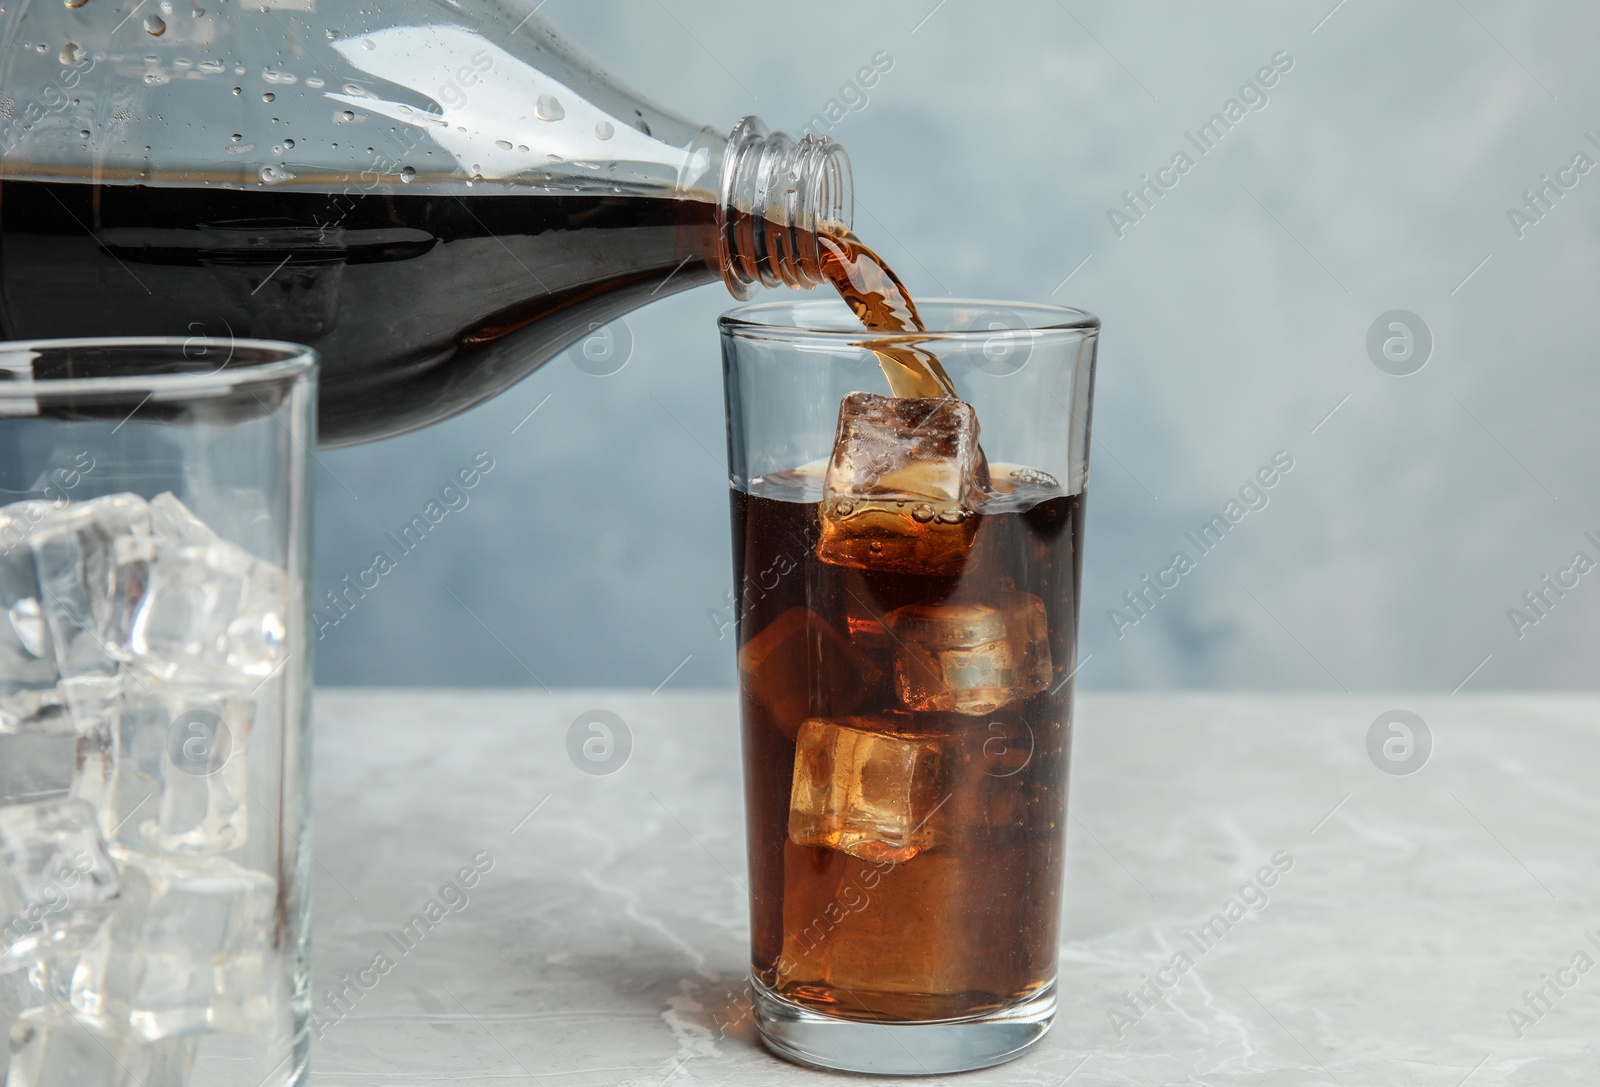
[733,472,1082,1021]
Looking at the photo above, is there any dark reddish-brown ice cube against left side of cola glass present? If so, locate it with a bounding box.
[739,607,885,740]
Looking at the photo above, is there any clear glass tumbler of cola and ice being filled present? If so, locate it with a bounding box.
[722,301,1099,1074]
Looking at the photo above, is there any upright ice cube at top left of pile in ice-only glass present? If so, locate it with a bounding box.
[32,495,155,695]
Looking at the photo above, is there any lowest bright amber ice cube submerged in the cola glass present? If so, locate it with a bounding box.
[789,717,949,861]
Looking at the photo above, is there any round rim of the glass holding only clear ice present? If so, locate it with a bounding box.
[0,336,318,402]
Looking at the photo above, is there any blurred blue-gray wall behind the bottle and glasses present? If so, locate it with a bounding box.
[314,0,1600,692]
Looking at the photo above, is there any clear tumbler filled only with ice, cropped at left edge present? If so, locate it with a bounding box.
[0,339,315,1087]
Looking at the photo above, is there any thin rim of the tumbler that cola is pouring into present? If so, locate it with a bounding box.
[717,298,1101,343]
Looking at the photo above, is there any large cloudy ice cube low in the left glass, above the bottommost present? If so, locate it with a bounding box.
[72,850,277,1041]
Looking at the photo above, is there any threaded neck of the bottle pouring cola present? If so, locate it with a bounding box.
[717,117,854,299]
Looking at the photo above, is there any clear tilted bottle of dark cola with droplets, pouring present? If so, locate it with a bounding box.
[0,0,853,445]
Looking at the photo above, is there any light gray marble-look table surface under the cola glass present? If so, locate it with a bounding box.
[310,690,1600,1087]
